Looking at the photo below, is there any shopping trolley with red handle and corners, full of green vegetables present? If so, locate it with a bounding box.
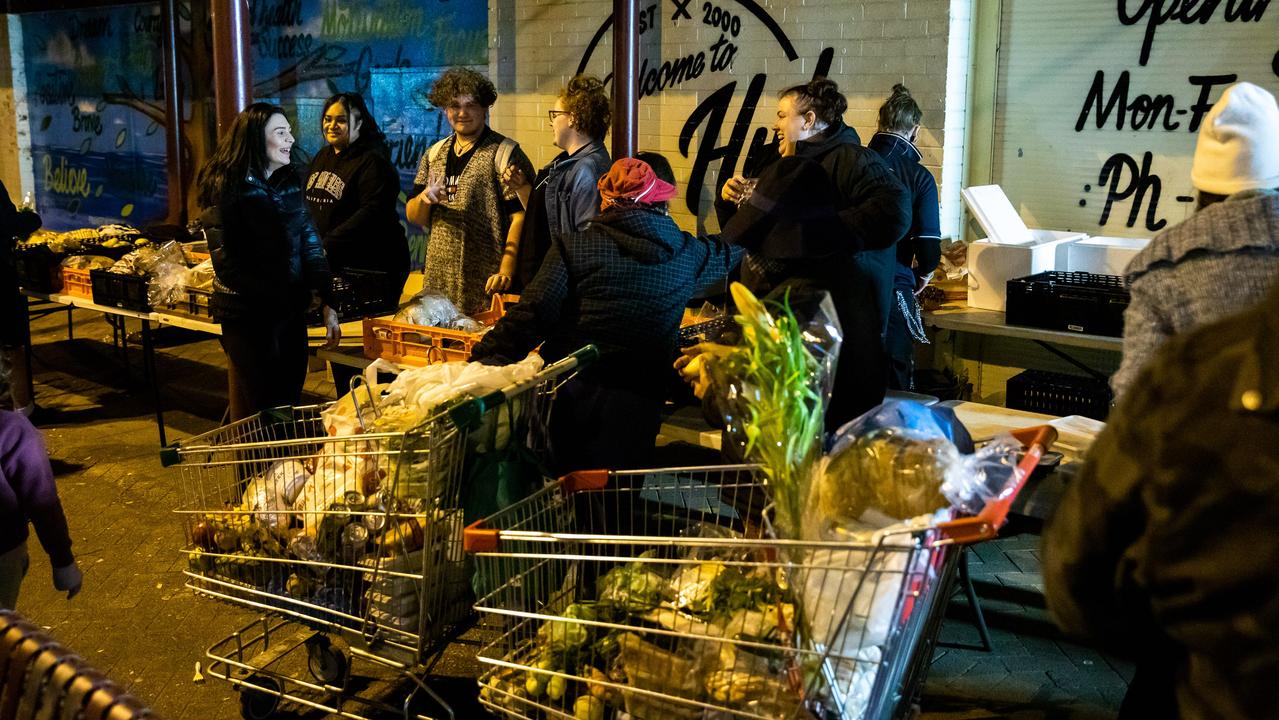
[466,428,1053,720]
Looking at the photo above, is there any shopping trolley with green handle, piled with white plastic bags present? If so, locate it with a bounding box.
[162,347,595,719]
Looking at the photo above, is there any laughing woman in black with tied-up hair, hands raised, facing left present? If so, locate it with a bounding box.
[716,78,911,427]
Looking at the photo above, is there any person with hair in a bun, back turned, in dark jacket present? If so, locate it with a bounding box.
[870,83,941,390]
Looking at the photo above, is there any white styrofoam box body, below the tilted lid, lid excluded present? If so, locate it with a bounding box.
[968,230,1085,312]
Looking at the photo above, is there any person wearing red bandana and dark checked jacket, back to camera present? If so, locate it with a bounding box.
[471,152,742,473]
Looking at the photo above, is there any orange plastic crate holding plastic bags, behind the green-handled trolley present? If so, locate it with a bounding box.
[365,294,519,366]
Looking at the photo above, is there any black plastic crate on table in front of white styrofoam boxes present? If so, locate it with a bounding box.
[1004,270,1129,338]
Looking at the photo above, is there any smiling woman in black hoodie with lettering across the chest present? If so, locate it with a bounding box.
[306,92,409,307]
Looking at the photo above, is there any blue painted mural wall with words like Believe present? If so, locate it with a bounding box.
[22,0,489,253]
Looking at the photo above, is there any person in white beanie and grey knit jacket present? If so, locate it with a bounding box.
[1110,82,1279,402]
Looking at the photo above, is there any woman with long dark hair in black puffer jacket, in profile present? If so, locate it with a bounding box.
[197,102,341,419]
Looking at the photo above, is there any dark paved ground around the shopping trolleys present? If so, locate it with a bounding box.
[4,311,1129,720]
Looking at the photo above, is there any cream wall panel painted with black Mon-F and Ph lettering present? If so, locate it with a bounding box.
[995,0,1279,237]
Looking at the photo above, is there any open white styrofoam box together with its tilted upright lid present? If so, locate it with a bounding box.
[961,185,1087,312]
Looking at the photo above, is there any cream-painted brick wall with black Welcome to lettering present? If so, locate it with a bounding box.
[490,0,968,231]
